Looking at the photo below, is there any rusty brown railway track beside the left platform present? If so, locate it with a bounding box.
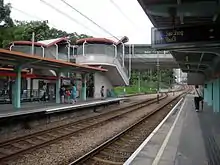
[0,95,167,164]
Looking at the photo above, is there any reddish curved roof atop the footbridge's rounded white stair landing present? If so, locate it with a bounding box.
[76,38,116,45]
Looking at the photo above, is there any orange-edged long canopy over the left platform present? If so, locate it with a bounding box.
[0,49,107,73]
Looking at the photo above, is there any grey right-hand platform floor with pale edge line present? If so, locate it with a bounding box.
[124,95,220,165]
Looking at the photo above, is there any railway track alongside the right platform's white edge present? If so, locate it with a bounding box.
[69,91,186,165]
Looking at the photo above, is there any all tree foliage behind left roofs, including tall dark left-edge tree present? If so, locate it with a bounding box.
[0,0,91,47]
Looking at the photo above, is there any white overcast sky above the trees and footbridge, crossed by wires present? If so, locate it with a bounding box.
[5,0,152,44]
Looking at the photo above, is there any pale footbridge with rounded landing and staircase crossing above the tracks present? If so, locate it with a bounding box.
[75,38,178,86]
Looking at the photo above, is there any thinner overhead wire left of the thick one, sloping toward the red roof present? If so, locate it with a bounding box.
[40,0,99,35]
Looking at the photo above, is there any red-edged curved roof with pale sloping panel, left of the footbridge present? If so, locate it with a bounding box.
[10,37,68,47]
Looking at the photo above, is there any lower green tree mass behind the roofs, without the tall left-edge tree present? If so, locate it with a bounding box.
[0,20,91,47]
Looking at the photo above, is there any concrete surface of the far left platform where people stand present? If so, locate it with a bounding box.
[0,94,156,118]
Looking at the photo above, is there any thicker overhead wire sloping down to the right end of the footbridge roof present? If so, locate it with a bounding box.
[60,0,120,40]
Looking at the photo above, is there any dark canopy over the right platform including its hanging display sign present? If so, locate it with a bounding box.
[138,0,220,78]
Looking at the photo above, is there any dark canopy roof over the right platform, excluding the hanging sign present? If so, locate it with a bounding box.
[138,0,220,77]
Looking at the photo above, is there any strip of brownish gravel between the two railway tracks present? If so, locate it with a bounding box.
[4,93,179,165]
